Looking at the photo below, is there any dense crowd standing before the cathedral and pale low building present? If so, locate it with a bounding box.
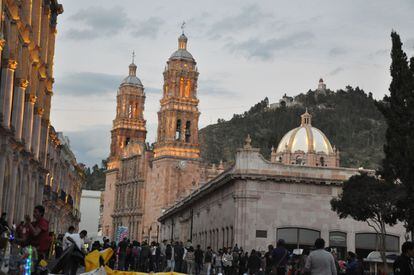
[86,238,364,275]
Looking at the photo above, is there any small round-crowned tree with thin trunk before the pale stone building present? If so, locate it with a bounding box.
[331,173,400,268]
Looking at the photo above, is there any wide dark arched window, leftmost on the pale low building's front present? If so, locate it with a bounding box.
[277,227,321,251]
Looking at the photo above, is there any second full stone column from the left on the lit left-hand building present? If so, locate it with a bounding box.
[12,79,29,141]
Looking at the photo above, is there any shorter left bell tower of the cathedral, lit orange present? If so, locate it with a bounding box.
[108,59,147,169]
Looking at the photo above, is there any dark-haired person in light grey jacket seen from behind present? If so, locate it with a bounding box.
[305,238,337,275]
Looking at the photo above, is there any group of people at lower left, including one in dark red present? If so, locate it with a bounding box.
[0,205,88,274]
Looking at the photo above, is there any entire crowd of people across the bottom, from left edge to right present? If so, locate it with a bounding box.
[0,208,414,275]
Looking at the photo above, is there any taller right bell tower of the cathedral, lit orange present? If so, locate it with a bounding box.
[154,32,200,159]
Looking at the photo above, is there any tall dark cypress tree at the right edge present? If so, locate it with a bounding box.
[377,32,414,232]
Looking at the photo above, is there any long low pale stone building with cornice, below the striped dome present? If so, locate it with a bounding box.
[159,117,405,258]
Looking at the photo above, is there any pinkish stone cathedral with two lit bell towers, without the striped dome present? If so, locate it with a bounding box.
[102,32,224,241]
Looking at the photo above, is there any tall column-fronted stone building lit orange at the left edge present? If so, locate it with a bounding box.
[0,0,81,229]
